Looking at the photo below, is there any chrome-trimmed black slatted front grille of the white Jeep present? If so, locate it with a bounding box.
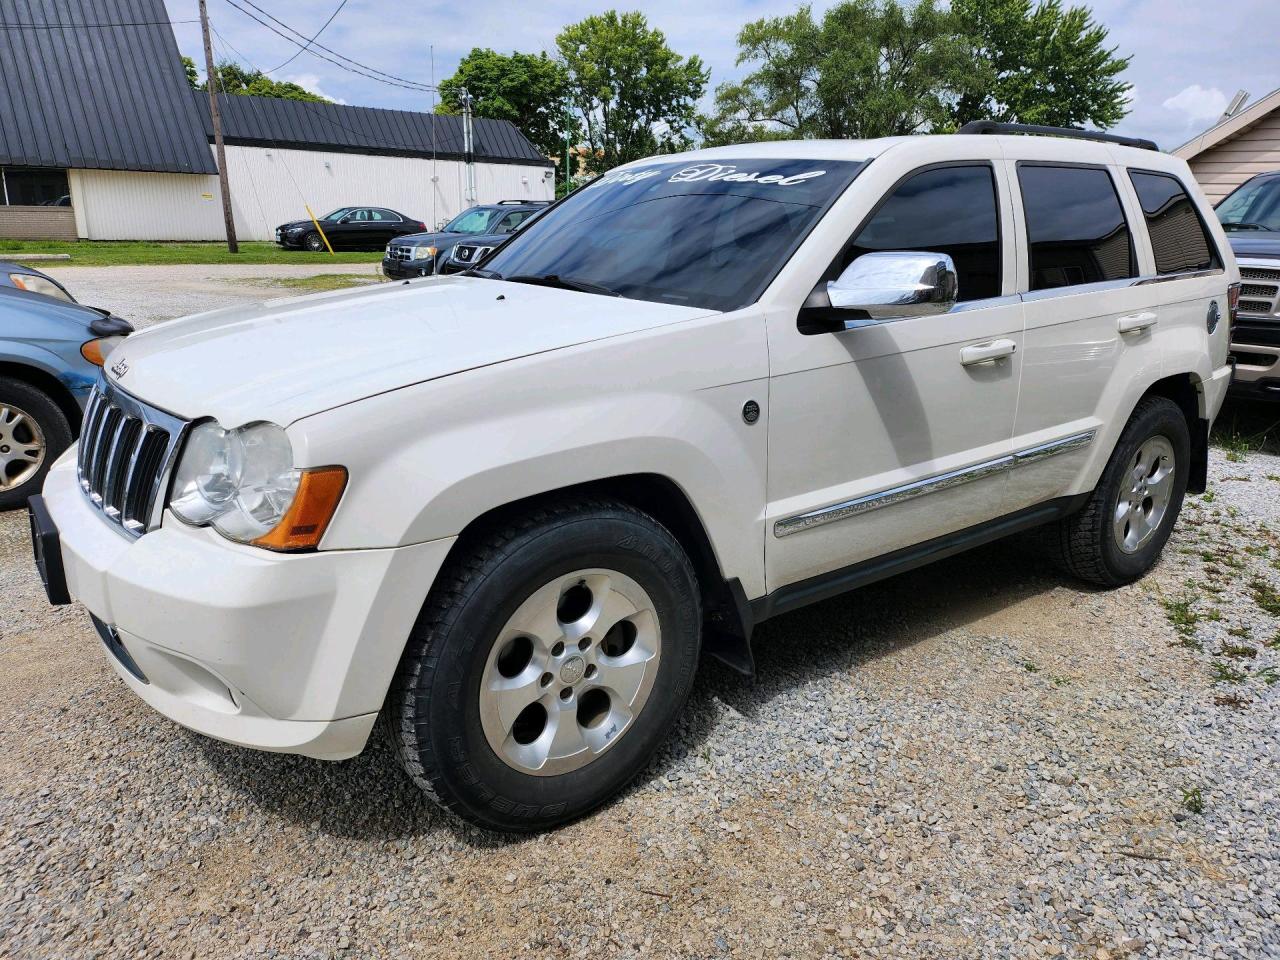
[76,383,186,536]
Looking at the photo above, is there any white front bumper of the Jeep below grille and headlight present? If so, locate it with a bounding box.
[44,448,453,760]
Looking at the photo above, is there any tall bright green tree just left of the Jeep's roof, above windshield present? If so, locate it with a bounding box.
[556,10,710,170]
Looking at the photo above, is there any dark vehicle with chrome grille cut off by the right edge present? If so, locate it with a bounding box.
[1217,170,1280,401]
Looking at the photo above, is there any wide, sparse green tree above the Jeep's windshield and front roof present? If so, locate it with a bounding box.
[703,0,984,143]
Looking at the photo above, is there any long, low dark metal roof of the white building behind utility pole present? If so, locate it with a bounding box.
[196,93,554,166]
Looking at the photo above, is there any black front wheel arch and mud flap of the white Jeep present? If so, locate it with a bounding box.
[445,474,754,675]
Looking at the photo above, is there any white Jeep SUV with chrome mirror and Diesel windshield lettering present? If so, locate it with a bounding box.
[32,128,1238,831]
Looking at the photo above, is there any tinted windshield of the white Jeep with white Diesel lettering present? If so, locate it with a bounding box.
[479,159,863,310]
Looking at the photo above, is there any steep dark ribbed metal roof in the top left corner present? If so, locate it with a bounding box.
[0,0,216,173]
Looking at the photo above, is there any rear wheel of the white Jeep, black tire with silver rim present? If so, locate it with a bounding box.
[1041,397,1190,588]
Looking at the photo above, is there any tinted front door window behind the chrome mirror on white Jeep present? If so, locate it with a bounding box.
[840,165,1001,301]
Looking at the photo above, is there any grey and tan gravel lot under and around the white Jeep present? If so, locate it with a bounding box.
[0,271,1280,960]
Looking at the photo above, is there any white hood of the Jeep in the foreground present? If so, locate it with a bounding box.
[106,276,712,428]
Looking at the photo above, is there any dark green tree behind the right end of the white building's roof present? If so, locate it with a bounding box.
[436,47,576,157]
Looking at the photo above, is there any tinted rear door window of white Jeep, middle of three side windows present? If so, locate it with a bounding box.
[1018,164,1135,291]
